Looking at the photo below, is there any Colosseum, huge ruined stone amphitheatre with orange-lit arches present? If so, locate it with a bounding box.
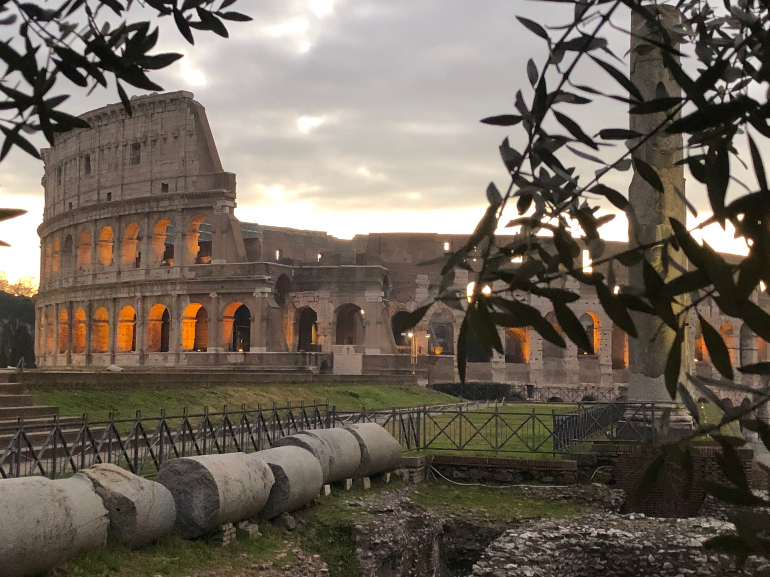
[35,92,770,402]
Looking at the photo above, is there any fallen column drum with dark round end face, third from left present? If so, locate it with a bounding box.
[158,453,274,539]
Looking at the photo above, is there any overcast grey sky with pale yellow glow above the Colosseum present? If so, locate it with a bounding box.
[0,0,752,280]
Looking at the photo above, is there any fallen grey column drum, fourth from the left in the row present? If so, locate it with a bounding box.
[255,446,324,519]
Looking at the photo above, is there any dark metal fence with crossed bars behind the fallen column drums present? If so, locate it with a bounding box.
[0,401,656,478]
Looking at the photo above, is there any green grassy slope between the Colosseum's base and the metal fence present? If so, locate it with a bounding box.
[30,384,459,420]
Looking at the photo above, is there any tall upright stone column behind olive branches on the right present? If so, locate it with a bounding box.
[628,6,691,414]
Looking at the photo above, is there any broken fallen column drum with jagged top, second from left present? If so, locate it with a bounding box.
[82,464,176,548]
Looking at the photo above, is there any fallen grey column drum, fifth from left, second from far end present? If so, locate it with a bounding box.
[273,429,361,484]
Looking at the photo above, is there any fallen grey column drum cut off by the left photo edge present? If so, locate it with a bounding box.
[0,474,109,577]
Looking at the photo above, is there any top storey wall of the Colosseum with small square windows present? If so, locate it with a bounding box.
[42,91,228,218]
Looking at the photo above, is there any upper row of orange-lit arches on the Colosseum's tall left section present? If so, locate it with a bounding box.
[43,215,213,277]
